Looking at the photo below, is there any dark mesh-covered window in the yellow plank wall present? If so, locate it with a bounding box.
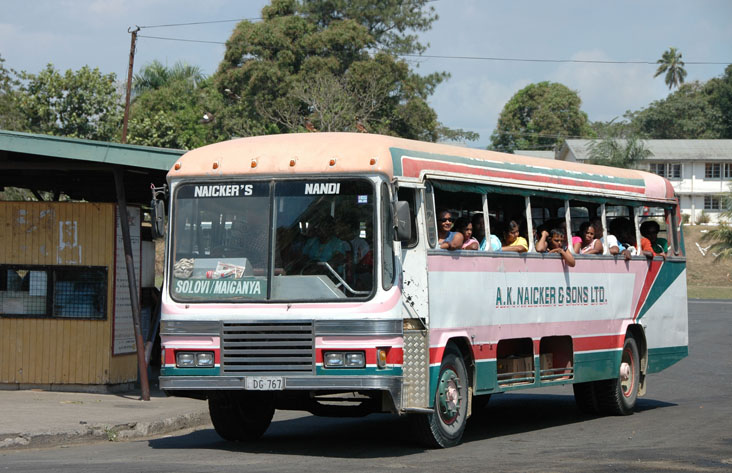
[0,265,107,319]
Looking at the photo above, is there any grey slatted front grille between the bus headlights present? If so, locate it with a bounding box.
[221,321,315,376]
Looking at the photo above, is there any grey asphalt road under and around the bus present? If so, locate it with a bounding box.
[0,301,732,473]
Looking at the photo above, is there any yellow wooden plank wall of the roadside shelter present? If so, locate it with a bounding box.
[0,202,137,384]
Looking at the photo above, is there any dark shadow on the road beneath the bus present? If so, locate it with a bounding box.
[149,393,675,459]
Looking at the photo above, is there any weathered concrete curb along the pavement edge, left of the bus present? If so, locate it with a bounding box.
[0,411,211,452]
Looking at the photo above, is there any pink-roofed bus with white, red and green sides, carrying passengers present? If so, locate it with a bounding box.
[153,133,688,448]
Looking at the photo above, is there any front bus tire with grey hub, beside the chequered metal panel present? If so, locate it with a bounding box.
[414,347,468,448]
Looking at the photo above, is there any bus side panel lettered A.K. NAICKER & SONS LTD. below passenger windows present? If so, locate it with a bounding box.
[428,252,686,394]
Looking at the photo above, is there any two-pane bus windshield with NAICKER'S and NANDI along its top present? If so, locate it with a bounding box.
[170,179,376,302]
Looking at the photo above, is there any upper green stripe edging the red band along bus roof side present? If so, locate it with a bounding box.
[389,148,645,187]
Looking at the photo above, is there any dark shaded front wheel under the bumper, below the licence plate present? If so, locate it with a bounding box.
[208,391,274,442]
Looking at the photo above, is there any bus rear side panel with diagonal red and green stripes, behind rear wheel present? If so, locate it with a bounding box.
[635,260,689,373]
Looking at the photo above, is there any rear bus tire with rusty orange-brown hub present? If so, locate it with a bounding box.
[595,334,640,416]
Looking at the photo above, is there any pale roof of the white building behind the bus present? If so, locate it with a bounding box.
[559,140,732,161]
